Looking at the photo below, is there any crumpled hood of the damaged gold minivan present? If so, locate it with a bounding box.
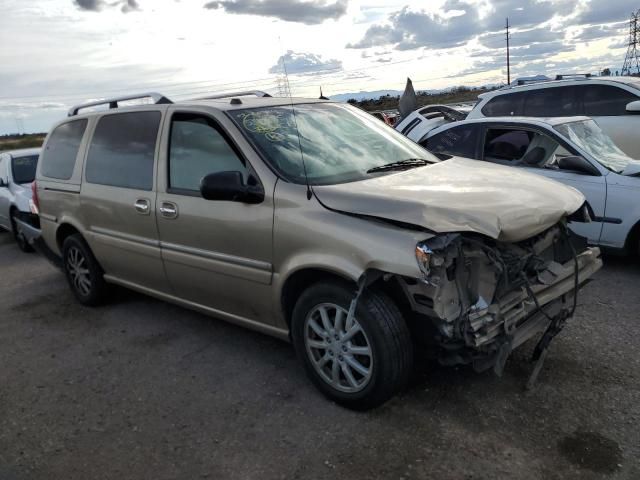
[313,157,585,242]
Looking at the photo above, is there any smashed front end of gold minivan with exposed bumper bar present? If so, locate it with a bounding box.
[403,234,602,374]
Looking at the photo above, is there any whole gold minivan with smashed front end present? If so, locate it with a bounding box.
[34,92,602,409]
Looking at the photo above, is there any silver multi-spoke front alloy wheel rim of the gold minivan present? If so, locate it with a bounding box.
[304,303,374,393]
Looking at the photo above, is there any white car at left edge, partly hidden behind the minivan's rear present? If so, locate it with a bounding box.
[0,148,40,252]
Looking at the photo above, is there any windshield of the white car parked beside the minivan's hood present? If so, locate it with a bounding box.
[555,120,636,173]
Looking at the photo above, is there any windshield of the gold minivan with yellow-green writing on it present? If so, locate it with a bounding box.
[230,103,438,185]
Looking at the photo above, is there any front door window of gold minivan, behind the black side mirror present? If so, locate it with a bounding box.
[169,114,248,192]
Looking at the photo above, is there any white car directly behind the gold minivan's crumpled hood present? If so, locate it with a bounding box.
[419,117,640,253]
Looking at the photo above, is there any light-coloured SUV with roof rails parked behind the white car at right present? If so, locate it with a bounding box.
[467,75,640,158]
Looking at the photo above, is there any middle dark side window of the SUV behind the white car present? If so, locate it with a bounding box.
[523,87,581,117]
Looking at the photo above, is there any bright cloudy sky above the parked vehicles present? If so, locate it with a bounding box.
[0,0,640,135]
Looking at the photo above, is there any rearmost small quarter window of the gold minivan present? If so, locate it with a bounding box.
[42,119,87,180]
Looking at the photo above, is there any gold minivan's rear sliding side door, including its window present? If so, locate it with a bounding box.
[80,110,170,293]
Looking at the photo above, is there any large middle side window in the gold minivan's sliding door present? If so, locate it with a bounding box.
[85,112,161,190]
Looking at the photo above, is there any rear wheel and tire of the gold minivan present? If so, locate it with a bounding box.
[62,233,109,306]
